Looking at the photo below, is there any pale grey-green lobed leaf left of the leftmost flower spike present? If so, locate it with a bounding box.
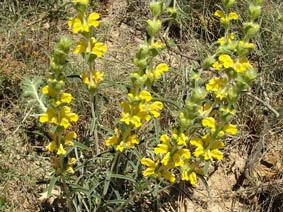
[21,77,47,112]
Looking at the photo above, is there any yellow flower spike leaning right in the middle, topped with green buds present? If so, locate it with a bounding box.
[106,0,168,152]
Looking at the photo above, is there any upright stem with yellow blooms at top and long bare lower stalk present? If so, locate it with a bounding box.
[68,0,107,154]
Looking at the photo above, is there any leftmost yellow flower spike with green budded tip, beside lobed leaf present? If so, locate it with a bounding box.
[39,37,78,175]
